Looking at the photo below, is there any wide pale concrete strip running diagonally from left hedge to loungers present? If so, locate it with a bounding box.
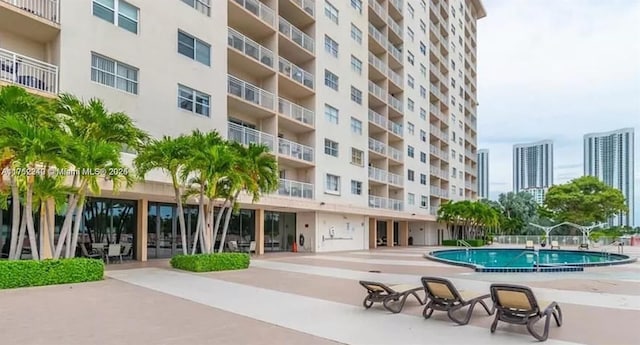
[107,268,576,345]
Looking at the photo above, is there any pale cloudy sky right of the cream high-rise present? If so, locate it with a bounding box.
[477,0,640,226]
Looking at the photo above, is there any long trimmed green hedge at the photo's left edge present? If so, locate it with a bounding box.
[0,258,104,289]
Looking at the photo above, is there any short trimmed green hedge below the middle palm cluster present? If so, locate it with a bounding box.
[171,253,250,272]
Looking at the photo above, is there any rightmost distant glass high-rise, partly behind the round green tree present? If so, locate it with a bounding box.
[584,128,635,226]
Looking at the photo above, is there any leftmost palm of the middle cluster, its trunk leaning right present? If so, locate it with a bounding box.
[134,135,191,255]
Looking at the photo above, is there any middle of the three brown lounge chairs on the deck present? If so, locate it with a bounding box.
[421,277,493,325]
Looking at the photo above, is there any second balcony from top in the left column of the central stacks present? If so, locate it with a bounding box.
[227,28,274,78]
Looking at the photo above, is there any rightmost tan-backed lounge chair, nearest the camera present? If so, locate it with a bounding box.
[490,284,562,341]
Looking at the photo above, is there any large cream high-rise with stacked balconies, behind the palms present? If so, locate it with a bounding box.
[0,0,486,260]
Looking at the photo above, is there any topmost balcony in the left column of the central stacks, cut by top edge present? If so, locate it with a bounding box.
[228,0,276,37]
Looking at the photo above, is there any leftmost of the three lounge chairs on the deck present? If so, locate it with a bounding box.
[360,281,426,314]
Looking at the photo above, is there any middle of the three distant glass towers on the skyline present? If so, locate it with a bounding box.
[513,140,553,193]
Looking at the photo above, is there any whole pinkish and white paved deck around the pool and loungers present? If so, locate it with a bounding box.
[0,243,640,345]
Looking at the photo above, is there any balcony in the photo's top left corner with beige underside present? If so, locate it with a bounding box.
[0,0,60,43]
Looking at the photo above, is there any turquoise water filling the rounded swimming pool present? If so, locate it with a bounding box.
[430,248,629,268]
